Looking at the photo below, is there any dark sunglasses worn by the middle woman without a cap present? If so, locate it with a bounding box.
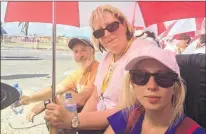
[93,21,119,39]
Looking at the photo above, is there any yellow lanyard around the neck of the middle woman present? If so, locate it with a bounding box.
[101,38,134,96]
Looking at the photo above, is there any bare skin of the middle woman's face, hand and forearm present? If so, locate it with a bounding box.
[44,12,128,130]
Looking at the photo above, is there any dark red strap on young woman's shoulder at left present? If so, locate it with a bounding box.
[126,107,144,134]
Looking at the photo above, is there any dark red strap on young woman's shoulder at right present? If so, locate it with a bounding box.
[175,117,200,134]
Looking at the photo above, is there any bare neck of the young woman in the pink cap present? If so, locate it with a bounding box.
[145,104,173,127]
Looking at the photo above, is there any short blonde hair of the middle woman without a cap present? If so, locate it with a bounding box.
[90,5,134,52]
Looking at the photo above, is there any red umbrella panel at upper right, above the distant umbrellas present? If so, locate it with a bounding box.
[136,1,205,26]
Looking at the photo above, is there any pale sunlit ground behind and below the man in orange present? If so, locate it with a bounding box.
[1,47,102,134]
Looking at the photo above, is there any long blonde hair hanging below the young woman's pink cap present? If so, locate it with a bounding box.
[118,72,186,124]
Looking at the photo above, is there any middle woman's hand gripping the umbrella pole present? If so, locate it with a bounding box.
[44,97,73,128]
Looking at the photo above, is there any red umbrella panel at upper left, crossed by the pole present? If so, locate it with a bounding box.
[5,1,79,26]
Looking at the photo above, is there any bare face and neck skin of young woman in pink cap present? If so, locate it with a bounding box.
[105,59,174,134]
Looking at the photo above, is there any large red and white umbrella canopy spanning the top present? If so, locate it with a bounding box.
[5,2,205,27]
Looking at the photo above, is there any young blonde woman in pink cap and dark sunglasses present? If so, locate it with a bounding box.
[105,46,206,134]
